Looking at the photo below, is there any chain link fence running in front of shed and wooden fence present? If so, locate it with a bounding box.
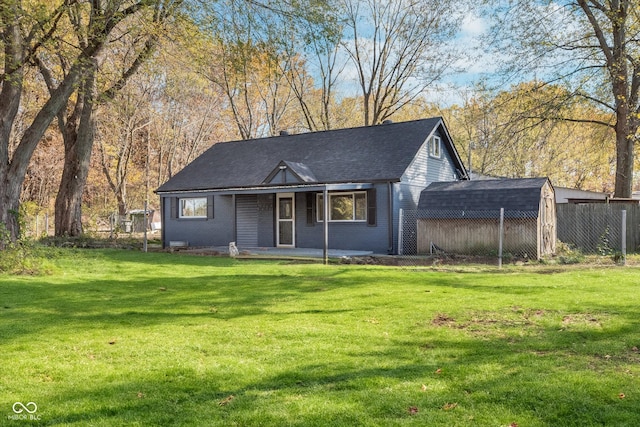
[398,204,640,265]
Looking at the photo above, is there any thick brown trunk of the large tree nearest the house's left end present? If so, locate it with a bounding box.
[55,61,96,236]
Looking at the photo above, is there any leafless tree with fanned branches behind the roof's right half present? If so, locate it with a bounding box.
[343,0,464,126]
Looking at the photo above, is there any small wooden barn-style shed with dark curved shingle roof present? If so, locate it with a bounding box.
[417,178,557,259]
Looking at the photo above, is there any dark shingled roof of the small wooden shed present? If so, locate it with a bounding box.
[418,178,549,212]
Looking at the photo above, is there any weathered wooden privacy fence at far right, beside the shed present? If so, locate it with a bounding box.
[556,203,640,255]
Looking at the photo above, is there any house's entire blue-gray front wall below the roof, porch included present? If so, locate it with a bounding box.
[162,183,393,259]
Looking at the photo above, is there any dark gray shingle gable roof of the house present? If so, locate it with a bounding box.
[157,117,462,192]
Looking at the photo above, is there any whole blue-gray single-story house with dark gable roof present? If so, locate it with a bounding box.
[156,117,467,254]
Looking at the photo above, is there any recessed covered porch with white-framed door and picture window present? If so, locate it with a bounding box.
[229,183,384,258]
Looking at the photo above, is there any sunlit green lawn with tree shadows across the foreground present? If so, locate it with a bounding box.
[0,249,640,426]
